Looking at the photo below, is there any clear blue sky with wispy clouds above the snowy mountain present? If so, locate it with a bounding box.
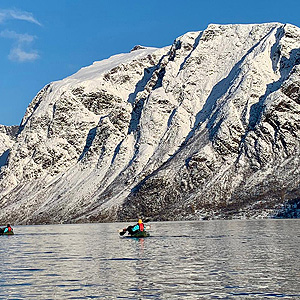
[0,0,300,125]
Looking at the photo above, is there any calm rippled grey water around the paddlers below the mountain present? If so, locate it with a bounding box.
[0,220,300,300]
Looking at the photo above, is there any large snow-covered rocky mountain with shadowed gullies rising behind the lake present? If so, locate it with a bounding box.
[0,23,300,223]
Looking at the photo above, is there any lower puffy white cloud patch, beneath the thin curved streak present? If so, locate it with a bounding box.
[0,30,40,62]
